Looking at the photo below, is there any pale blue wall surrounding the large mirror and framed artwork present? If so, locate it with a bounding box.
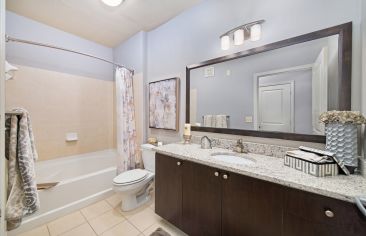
[147,0,361,141]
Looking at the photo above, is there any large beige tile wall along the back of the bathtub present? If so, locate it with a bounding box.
[6,65,115,160]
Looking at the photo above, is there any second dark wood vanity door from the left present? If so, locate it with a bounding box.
[183,162,221,236]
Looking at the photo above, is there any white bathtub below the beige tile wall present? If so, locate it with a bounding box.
[9,149,117,235]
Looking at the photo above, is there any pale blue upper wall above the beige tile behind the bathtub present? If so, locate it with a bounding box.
[6,11,113,80]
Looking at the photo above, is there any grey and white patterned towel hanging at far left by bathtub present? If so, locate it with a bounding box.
[5,108,40,230]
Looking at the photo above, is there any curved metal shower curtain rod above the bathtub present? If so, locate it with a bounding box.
[5,35,134,74]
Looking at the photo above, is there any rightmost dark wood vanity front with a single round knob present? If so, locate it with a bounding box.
[284,189,366,236]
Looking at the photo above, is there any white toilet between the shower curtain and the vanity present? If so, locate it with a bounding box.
[113,144,155,211]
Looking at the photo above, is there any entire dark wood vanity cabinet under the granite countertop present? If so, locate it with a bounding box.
[155,153,366,236]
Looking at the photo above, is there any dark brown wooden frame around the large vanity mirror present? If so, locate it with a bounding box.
[186,22,352,143]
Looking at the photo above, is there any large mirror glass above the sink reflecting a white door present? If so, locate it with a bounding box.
[190,35,339,135]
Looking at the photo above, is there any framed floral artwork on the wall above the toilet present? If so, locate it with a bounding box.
[149,78,179,131]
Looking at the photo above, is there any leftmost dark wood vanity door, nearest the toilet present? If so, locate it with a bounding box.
[155,153,183,228]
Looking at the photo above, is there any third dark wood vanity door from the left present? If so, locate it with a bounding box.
[222,173,283,236]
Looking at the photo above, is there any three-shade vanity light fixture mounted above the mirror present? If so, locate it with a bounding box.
[220,20,264,50]
